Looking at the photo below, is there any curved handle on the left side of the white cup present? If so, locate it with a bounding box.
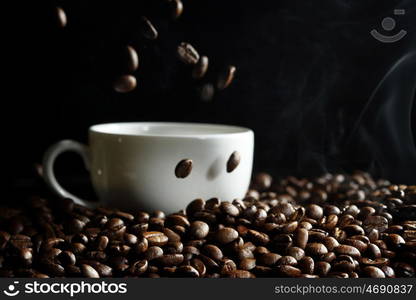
[43,140,95,208]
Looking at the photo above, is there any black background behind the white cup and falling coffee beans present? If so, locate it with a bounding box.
[2,0,416,199]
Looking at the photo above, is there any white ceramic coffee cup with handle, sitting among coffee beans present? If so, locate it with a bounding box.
[43,122,254,213]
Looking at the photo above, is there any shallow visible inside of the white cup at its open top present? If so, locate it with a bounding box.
[90,122,251,137]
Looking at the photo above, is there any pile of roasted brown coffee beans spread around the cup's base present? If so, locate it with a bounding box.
[0,172,416,278]
